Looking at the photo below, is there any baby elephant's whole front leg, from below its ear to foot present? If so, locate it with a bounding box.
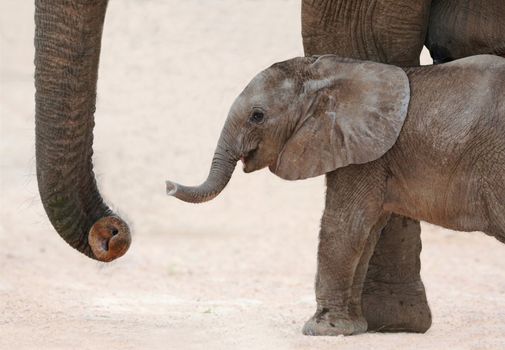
[303,166,384,335]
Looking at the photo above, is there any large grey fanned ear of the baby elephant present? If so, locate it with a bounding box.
[273,55,410,180]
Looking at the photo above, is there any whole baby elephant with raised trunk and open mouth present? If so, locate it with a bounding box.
[167,55,505,335]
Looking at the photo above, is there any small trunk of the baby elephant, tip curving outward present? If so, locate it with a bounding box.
[166,126,240,203]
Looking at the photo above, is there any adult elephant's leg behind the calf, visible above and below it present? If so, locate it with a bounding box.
[302,0,431,332]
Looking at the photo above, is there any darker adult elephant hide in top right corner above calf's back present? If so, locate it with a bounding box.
[426,0,505,63]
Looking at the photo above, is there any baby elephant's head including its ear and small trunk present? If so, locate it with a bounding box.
[167,55,410,203]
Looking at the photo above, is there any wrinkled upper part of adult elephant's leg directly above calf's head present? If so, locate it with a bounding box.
[302,0,431,67]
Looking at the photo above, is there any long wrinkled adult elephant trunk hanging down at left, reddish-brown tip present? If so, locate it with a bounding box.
[35,0,131,261]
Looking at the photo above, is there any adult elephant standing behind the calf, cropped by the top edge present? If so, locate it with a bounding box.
[302,0,505,332]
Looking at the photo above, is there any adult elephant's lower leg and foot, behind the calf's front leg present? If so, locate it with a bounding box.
[362,215,431,333]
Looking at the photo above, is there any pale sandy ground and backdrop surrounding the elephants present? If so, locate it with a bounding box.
[0,0,505,350]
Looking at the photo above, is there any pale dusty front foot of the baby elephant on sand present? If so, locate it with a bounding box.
[302,307,367,336]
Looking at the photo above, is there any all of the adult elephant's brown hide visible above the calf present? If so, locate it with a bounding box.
[302,0,505,66]
